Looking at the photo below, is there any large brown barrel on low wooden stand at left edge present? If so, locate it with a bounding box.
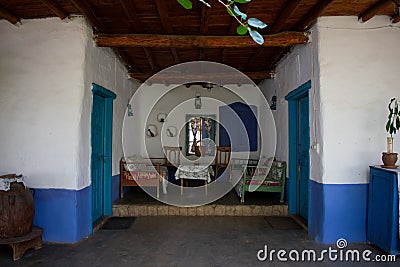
[0,182,35,239]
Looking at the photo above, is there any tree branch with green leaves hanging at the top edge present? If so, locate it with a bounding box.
[177,0,267,45]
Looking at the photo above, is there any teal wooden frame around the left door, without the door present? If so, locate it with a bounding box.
[90,83,117,225]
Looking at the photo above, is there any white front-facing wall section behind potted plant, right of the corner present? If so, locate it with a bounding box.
[318,16,400,184]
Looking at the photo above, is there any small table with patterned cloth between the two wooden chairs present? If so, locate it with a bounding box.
[175,164,214,195]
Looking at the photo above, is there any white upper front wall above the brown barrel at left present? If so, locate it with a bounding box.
[0,18,85,189]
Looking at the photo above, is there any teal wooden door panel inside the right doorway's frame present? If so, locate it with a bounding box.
[297,96,310,220]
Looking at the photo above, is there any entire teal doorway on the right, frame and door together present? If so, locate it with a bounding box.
[285,81,311,221]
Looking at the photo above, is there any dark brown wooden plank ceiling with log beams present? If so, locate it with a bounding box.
[0,0,400,82]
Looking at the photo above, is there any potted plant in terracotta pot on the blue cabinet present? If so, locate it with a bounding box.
[382,98,400,168]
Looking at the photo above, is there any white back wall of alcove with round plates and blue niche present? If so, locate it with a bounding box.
[123,84,275,160]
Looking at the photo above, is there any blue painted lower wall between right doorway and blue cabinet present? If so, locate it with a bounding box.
[308,180,368,244]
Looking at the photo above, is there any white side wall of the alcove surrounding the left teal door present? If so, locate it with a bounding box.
[77,22,139,188]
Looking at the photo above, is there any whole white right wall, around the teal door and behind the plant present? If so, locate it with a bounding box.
[260,16,400,184]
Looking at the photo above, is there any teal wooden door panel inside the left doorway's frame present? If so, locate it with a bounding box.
[91,94,105,222]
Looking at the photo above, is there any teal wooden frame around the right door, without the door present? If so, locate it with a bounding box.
[285,81,311,224]
